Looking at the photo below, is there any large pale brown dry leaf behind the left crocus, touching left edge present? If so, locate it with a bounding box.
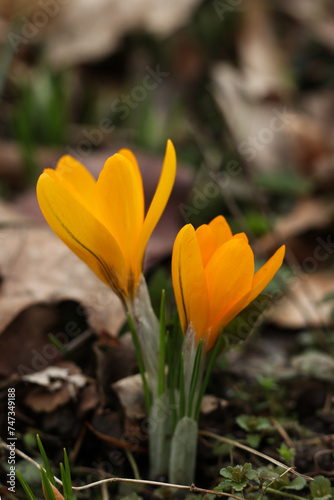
[0,227,125,338]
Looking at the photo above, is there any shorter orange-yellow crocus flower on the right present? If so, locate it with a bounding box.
[172,216,285,350]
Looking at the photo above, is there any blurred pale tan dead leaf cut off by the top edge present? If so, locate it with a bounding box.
[15,0,200,66]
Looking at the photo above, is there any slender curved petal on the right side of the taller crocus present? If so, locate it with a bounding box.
[137,140,176,269]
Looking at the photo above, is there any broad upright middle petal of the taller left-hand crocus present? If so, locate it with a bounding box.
[95,153,144,274]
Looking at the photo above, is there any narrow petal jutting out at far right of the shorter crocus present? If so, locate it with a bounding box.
[219,245,285,330]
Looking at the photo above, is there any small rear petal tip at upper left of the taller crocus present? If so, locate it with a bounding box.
[53,155,96,207]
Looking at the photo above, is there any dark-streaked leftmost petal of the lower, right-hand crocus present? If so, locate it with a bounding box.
[172,224,209,338]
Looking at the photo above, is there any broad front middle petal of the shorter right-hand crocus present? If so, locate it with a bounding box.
[205,238,254,326]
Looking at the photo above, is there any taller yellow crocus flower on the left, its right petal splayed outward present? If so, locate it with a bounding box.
[37,140,176,305]
